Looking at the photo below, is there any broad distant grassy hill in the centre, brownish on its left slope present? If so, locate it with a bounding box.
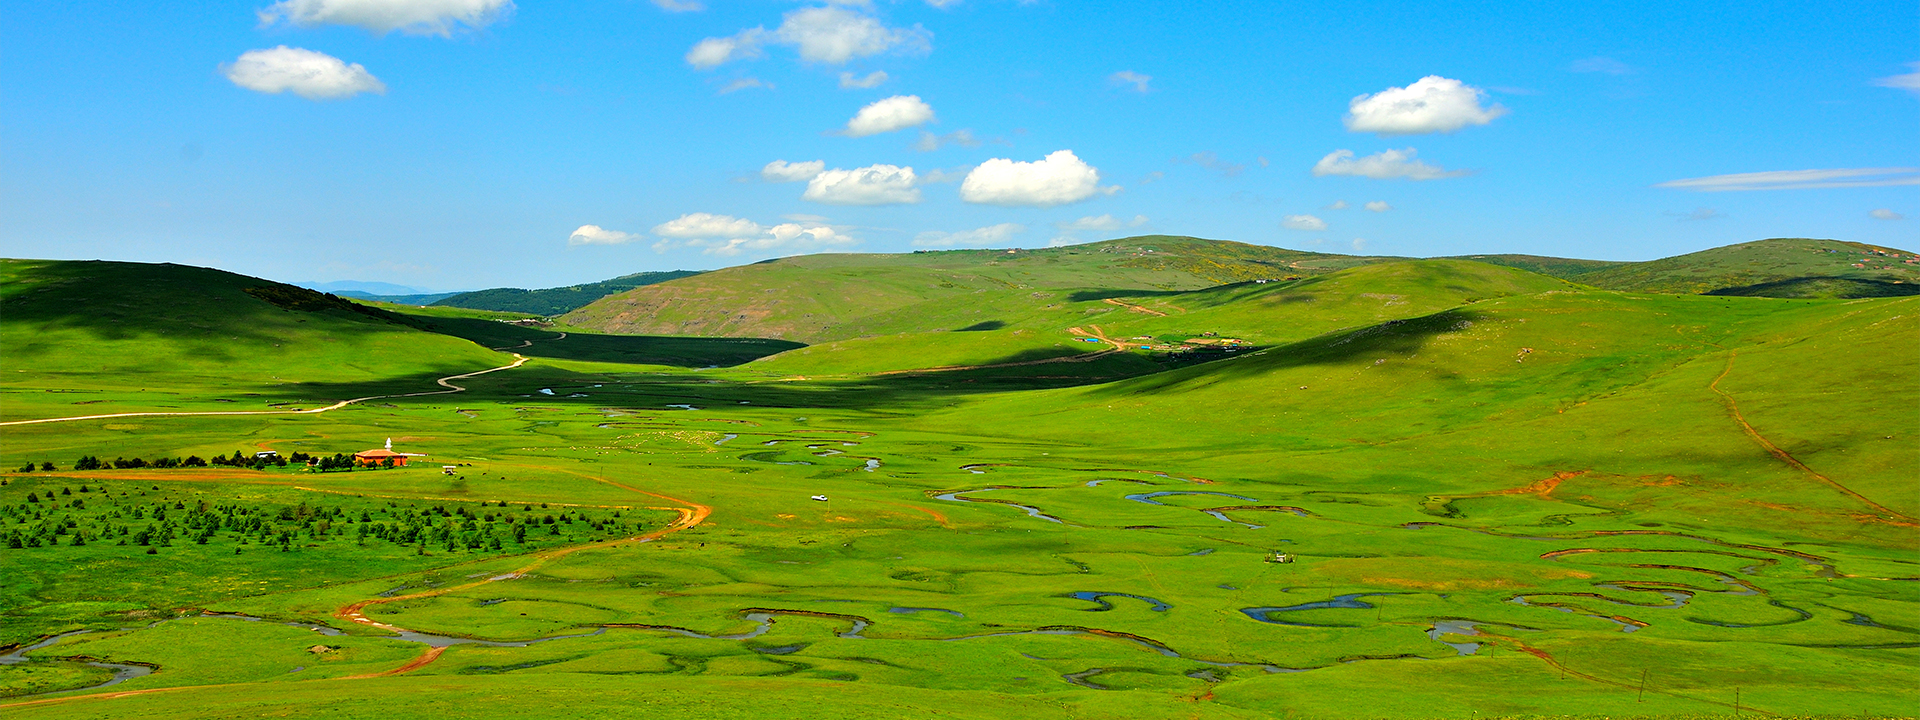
[564,236,1382,344]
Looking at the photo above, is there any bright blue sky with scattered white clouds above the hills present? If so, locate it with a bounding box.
[0,0,1920,290]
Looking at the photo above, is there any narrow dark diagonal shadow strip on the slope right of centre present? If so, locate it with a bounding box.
[1112,309,1486,401]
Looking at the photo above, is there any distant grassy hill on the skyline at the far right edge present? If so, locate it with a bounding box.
[1576,238,1920,298]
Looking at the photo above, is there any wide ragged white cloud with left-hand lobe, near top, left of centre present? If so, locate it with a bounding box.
[687,6,933,69]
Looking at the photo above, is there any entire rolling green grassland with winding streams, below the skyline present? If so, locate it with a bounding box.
[0,238,1920,718]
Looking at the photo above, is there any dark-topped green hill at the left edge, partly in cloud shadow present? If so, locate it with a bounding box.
[0,259,511,419]
